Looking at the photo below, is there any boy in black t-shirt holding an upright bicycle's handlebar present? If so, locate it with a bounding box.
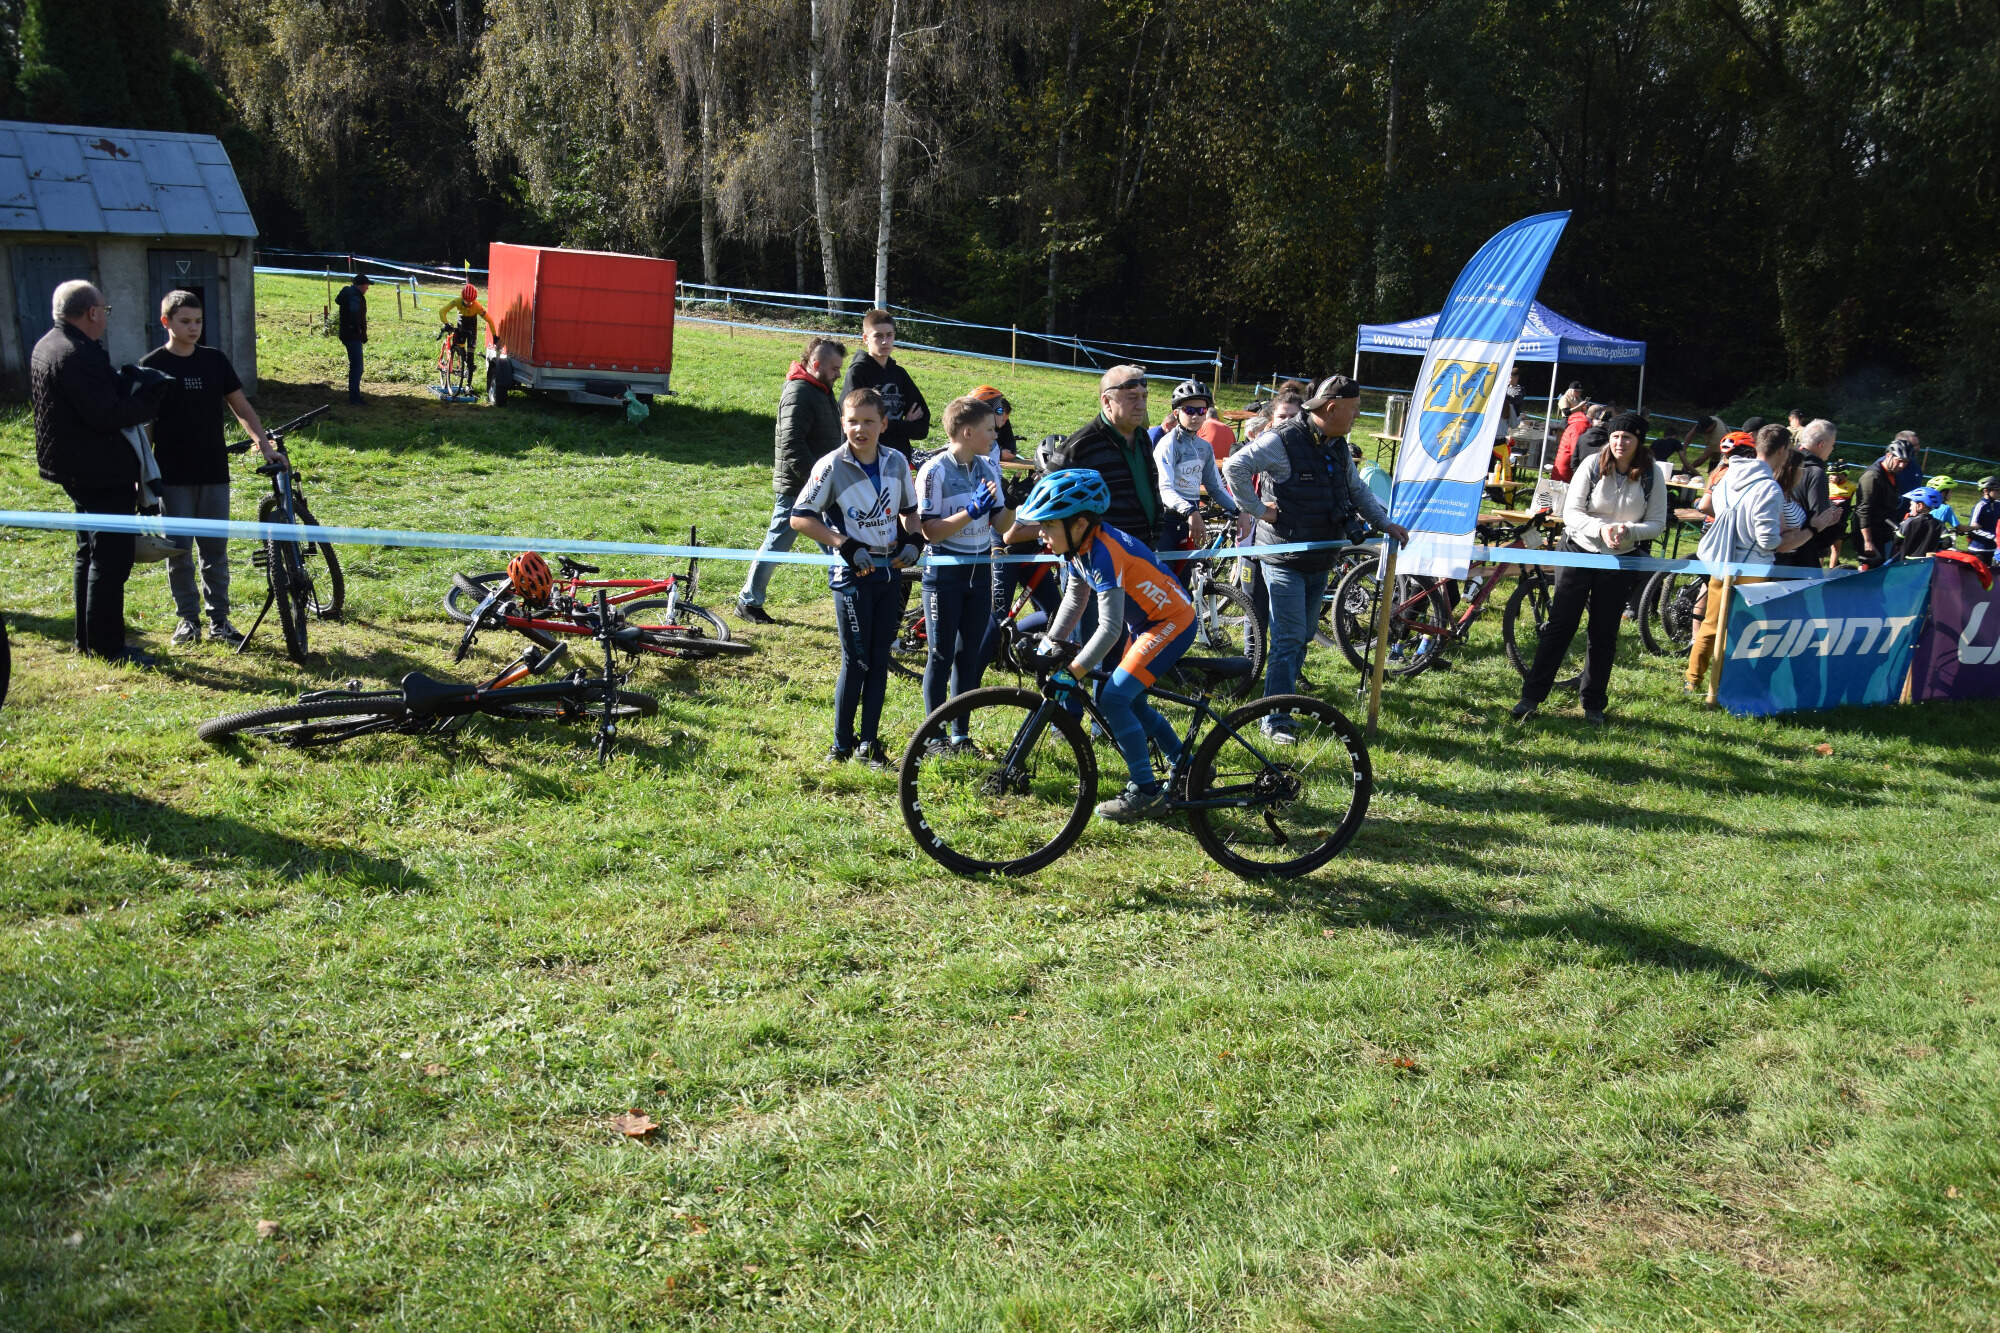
[140,292,280,646]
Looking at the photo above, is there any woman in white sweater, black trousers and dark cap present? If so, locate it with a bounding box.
[1514,412,1666,723]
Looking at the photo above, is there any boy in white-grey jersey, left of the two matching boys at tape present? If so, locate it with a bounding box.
[792,388,924,769]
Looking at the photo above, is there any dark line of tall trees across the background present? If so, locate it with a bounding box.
[0,0,2000,430]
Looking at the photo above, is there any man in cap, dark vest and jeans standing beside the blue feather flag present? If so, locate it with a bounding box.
[1222,374,1410,743]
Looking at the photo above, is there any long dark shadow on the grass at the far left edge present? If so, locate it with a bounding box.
[0,783,430,893]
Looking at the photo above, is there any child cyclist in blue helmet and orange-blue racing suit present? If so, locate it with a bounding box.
[1020,468,1194,825]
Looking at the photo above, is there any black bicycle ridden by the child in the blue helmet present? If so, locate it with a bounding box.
[896,640,1374,877]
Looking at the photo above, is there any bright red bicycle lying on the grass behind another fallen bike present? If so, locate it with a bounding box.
[444,528,756,658]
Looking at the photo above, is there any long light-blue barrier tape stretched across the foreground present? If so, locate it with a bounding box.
[0,508,1852,580]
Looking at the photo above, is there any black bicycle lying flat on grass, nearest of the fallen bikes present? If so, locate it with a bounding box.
[194,592,660,763]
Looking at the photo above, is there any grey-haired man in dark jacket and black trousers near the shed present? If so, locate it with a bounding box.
[28,280,168,667]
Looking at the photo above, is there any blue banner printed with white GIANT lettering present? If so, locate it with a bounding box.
[1716,560,1930,717]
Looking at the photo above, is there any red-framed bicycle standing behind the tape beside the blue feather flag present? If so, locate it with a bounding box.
[1328,510,1582,689]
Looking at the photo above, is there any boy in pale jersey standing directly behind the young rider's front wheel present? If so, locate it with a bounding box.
[916,396,1014,747]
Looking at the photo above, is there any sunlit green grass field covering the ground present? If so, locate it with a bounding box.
[0,280,2000,1331]
